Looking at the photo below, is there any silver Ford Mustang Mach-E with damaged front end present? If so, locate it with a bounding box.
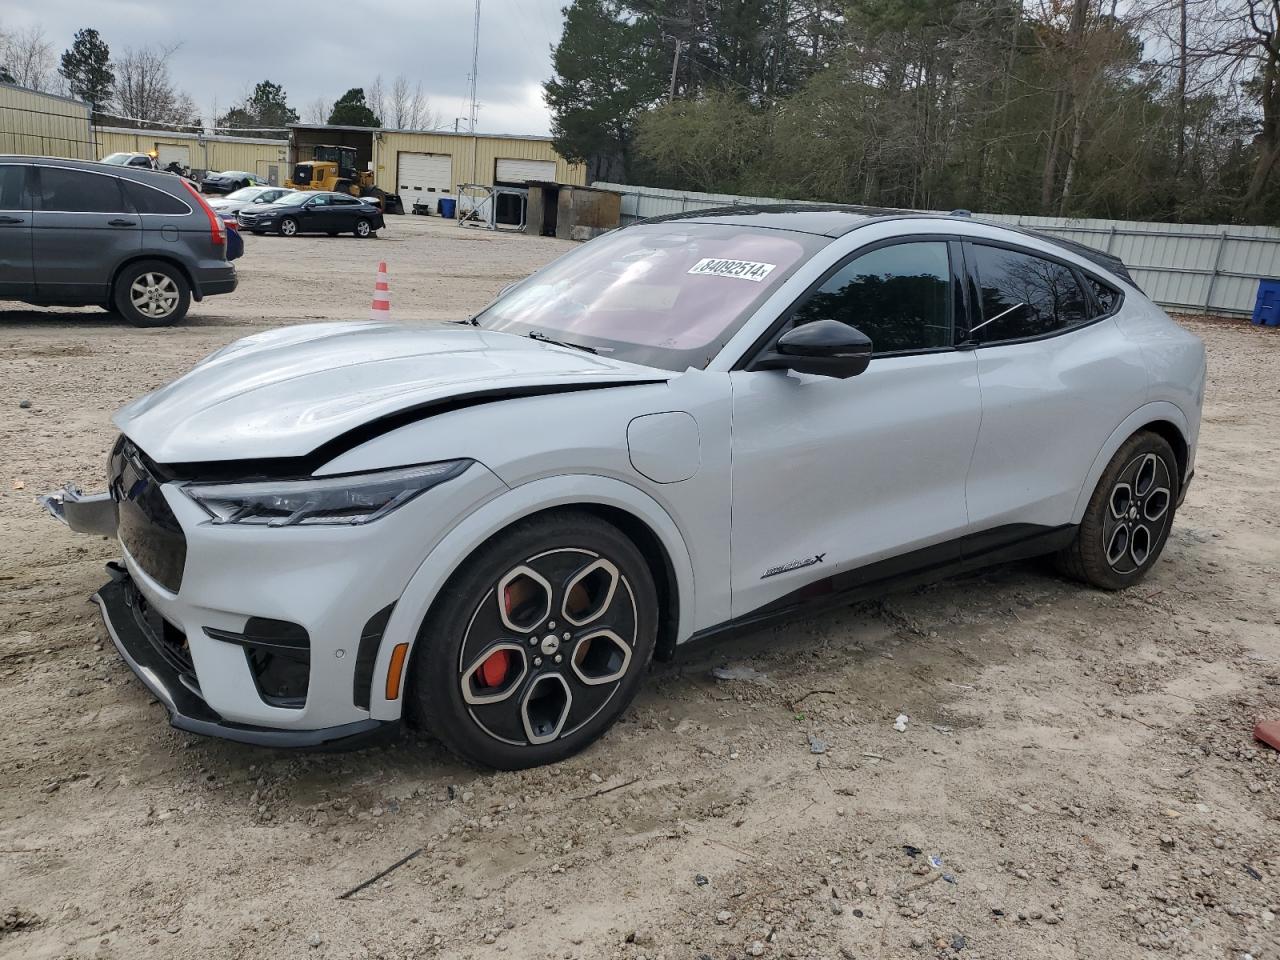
[45,207,1204,768]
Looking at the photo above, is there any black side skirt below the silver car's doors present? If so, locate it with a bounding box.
[681,524,1076,645]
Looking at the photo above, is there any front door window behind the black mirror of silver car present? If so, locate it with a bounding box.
[792,241,951,355]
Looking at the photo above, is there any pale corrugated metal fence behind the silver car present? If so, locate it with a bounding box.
[593,182,1280,315]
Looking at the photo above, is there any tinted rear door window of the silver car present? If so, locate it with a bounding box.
[970,243,1089,343]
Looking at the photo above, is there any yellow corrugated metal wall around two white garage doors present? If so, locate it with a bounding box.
[375,131,586,193]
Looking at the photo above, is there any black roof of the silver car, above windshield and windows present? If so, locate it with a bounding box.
[643,204,1133,283]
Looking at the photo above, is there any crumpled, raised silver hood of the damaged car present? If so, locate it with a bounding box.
[114,321,671,463]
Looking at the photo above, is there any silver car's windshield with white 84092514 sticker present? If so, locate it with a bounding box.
[475,220,829,370]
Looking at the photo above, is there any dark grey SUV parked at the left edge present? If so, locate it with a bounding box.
[0,155,236,326]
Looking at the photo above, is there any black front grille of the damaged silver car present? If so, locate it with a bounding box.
[108,436,187,593]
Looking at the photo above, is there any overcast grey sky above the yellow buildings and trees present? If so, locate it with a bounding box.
[0,0,567,134]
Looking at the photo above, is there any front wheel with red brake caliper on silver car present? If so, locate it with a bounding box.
[406,511,658,771]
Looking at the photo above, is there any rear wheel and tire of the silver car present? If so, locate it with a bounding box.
[1057,430,1179,590]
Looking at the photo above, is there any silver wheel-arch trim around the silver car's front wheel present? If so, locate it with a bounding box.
[370,475,694,719]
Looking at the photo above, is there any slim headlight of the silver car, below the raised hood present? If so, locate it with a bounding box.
[182,460,472,526]
